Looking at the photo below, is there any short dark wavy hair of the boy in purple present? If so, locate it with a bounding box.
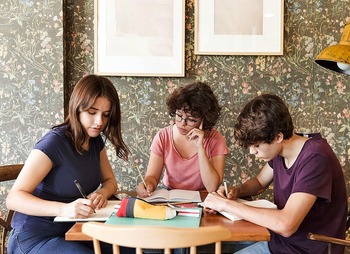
[234,94,294,148]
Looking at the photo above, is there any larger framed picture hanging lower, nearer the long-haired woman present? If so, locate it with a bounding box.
[94,0,185,77]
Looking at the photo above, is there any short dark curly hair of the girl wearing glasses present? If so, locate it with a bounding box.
[166,82,221,130]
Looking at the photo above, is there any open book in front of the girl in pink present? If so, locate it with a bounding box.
[143,189,202,203]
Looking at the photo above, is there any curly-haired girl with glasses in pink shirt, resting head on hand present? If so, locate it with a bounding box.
[136,82,228,197]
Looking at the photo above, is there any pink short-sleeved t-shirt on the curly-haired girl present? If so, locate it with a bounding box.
[151,126,228,190]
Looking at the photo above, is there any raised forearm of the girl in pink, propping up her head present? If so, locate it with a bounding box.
[198,148,224,192]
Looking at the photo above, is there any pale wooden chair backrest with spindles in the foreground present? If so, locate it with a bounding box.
[82,222,231,254]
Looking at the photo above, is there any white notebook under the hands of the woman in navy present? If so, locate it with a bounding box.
[54,200,121,222]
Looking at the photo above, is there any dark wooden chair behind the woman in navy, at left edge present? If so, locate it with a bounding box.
[0,164,23,254]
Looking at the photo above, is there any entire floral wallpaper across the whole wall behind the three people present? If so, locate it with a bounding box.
[0,0,350,239]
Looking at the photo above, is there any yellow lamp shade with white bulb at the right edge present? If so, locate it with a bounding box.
[315,22,350,75]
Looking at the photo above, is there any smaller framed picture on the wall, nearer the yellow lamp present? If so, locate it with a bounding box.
[195,0,283,55]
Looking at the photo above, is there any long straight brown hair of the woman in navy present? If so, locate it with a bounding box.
[53,74,130,161]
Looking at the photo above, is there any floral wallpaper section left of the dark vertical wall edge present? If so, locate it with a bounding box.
[0,0,63,217]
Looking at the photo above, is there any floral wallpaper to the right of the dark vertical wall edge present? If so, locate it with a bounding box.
[66,0,350,198]
